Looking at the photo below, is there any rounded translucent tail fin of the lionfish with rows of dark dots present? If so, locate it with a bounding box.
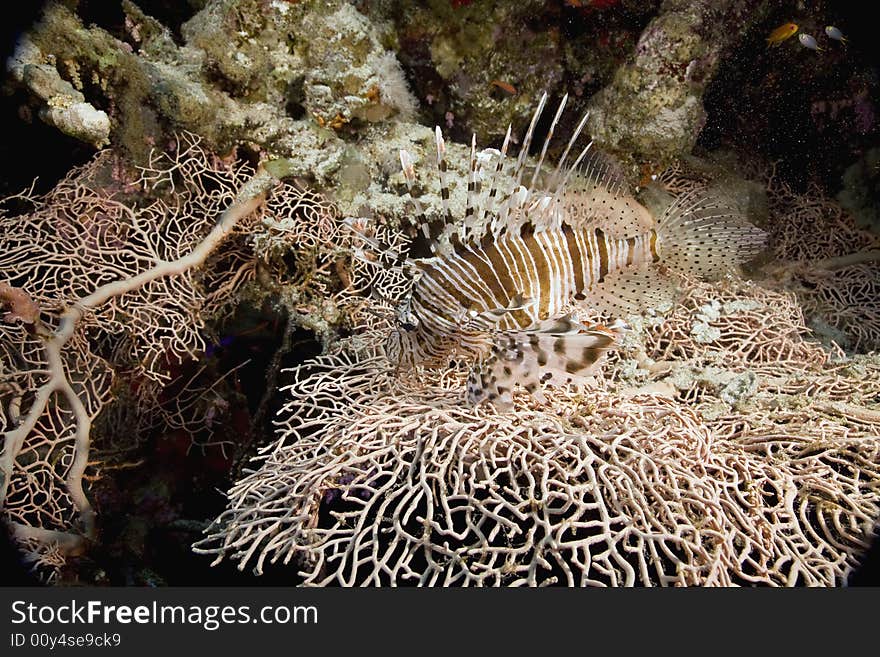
[657,190,767,279]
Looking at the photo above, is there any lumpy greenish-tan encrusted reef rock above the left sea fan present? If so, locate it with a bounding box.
[8,0,415,187]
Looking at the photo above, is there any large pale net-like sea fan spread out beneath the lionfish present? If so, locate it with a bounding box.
[195,206,880,586]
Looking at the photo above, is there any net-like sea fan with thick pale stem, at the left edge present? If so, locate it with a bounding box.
[0,135,282,570]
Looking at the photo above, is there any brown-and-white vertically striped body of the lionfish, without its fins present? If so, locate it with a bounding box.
[402,225,659,362]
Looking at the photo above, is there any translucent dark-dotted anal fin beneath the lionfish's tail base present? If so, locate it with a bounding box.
[582,266,679,317]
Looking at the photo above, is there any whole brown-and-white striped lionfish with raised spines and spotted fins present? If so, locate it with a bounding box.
[348,93,765,408]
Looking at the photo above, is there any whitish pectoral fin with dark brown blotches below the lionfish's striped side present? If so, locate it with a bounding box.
[467,324,623,409]
